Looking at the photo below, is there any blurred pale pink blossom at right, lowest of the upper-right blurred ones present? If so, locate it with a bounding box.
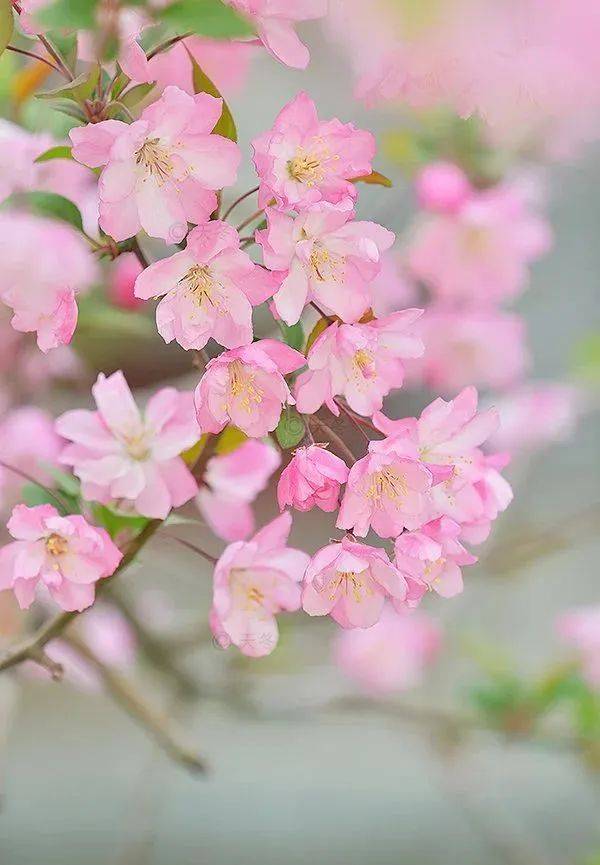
[491,381,581,452]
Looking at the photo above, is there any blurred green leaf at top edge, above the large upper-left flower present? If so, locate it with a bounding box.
[158,0,254,39]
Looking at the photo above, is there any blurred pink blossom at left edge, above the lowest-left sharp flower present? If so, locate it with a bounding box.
[0,405,63,504]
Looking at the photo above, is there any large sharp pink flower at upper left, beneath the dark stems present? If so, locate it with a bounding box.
[70,87,241,243]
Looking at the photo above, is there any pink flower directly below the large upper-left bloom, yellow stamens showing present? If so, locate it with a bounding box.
[135,221,275,349]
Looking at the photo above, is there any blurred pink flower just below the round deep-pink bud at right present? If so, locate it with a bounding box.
[408,187,551,304]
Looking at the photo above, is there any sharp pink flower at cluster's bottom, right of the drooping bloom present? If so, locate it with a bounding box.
[302,537,407,628]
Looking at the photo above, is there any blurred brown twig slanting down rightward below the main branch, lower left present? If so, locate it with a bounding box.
[64,634,207,772]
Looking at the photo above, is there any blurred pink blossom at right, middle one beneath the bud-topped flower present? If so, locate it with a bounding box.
[407,305,529,393]
